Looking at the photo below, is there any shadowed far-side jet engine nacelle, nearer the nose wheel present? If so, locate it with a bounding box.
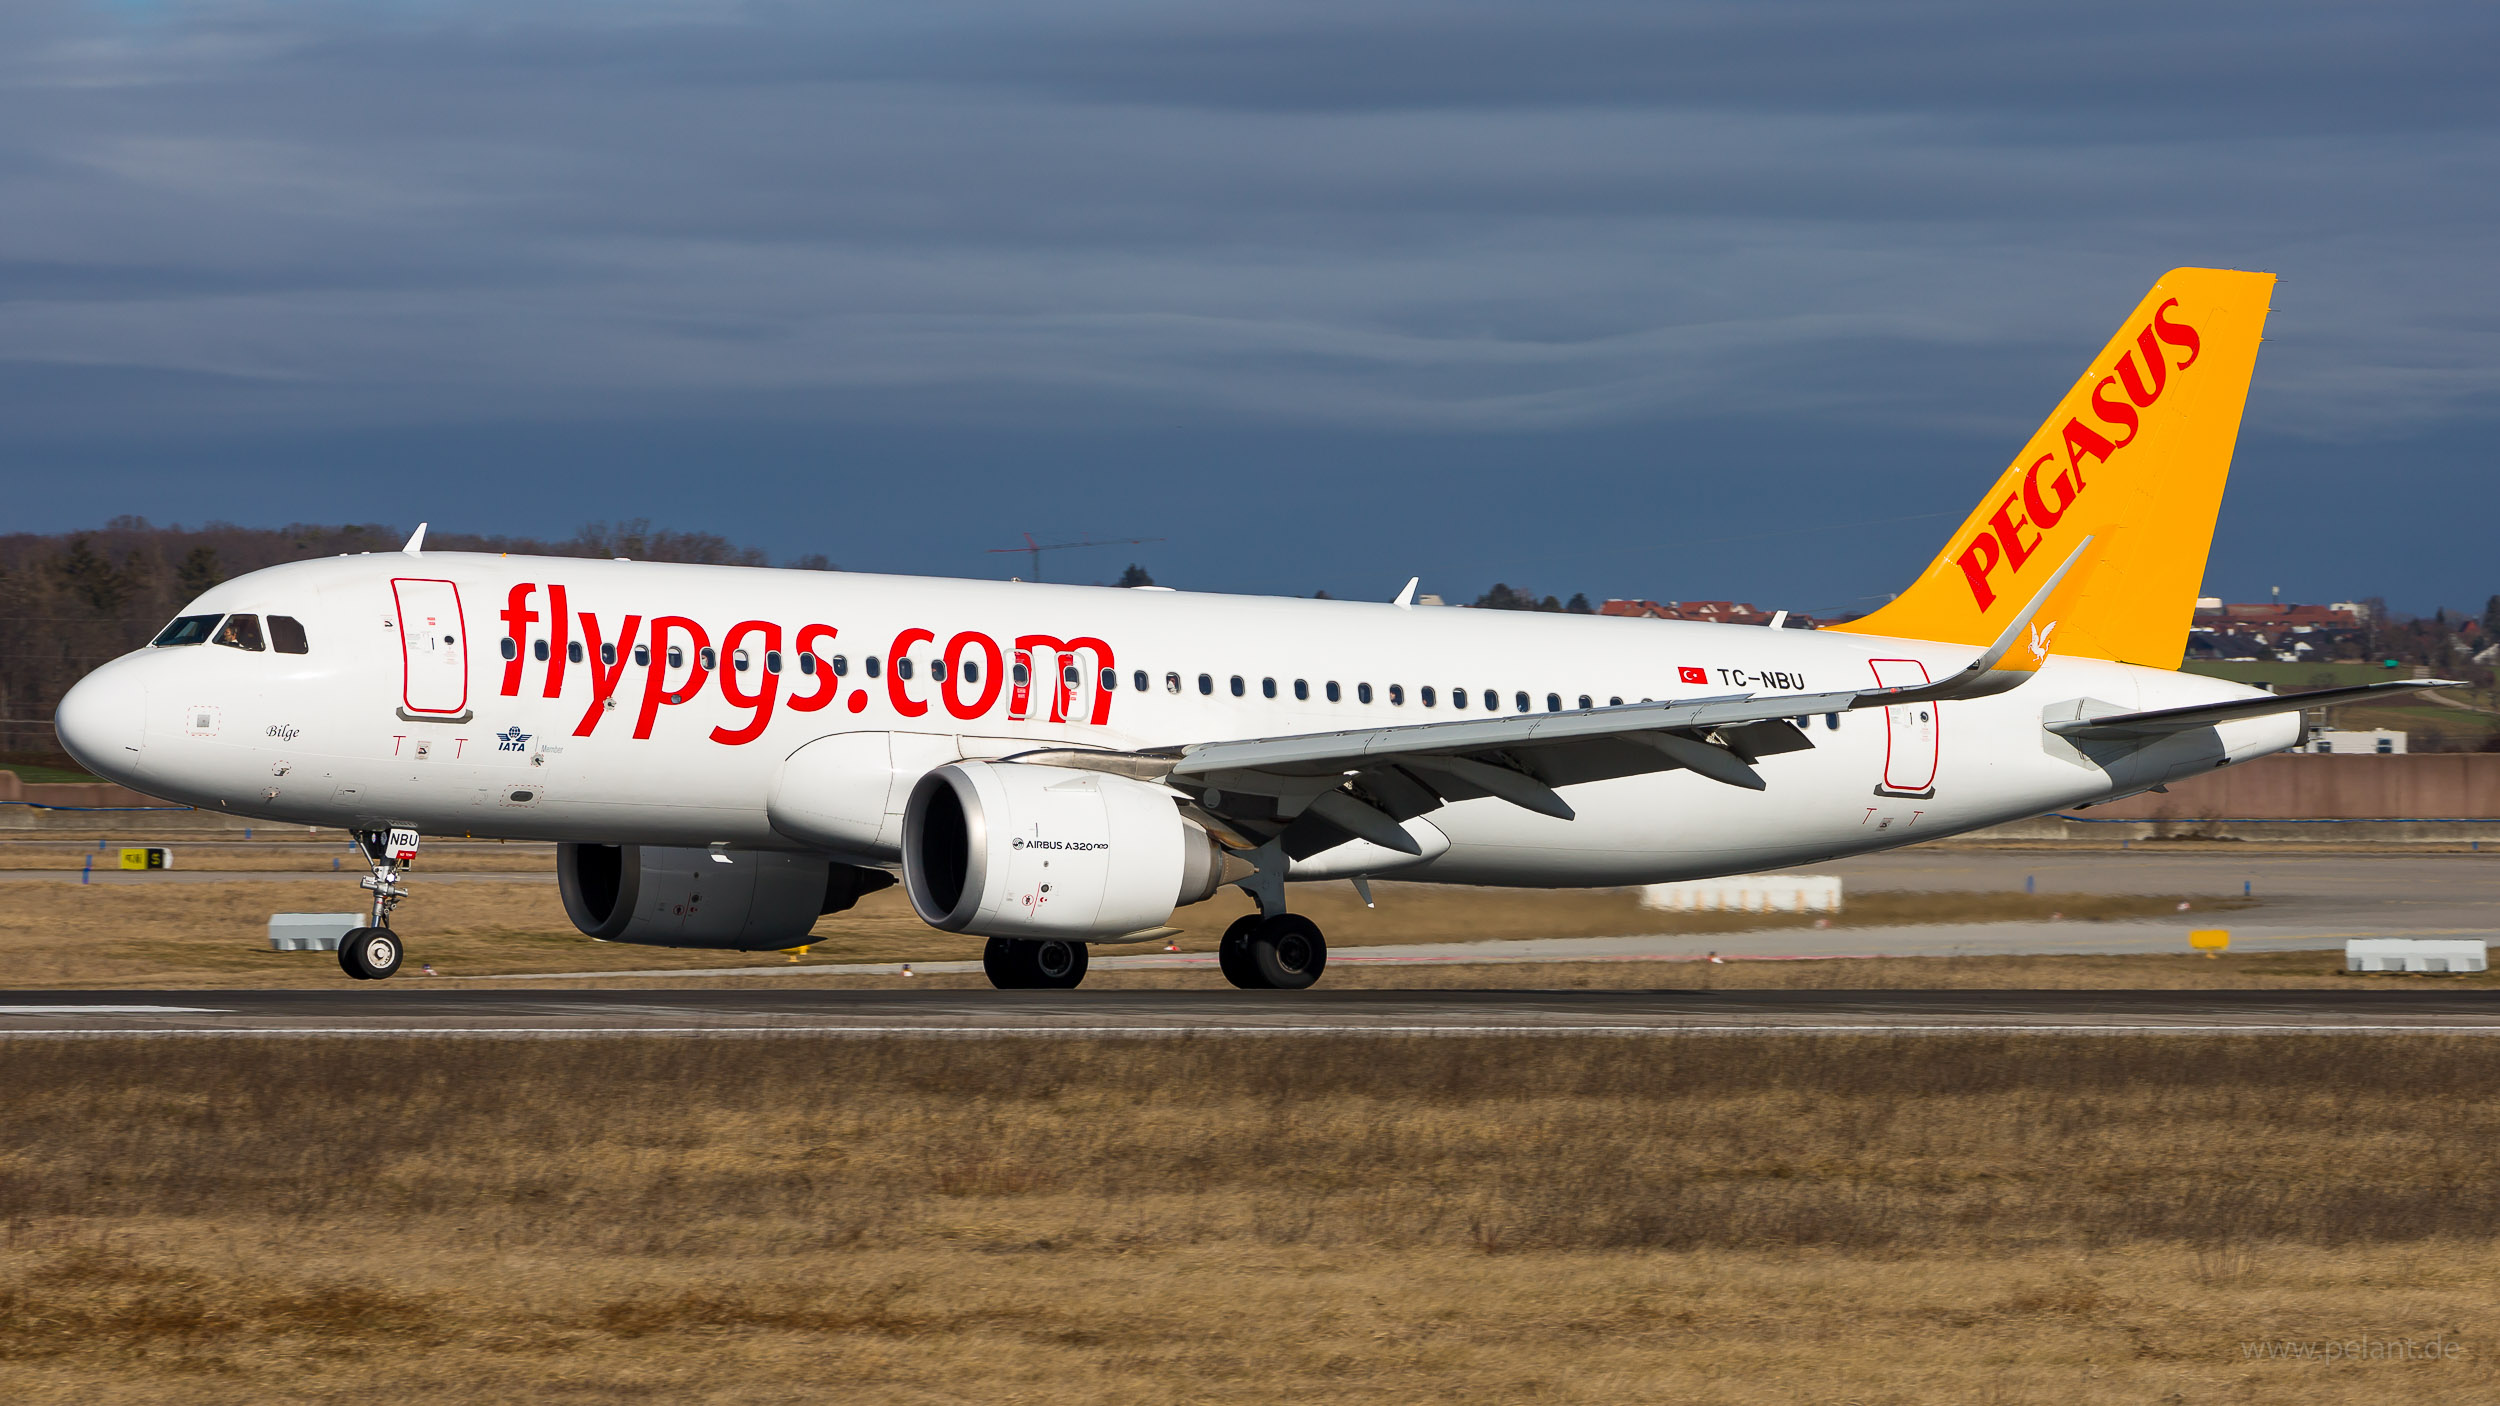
[555,843,895,951]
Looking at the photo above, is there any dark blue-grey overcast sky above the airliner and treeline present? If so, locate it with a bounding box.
[0,0,2500,610]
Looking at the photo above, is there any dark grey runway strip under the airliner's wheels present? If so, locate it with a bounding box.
[0,988,2500,1038]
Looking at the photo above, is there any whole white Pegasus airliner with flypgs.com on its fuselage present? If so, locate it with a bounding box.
[58,268,2428,988]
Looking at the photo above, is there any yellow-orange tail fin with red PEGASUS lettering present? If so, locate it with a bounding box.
[1833,268,2275,668]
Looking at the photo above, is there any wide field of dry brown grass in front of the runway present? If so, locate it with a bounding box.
[0,1036,2500,1403]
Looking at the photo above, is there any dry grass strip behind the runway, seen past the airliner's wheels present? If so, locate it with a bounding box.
[0,871,2243,988]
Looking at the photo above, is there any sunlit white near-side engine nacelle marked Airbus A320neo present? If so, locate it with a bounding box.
[903,761,1228,941]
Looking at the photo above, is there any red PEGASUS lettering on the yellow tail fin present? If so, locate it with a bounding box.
[1955,298,2203,610]
